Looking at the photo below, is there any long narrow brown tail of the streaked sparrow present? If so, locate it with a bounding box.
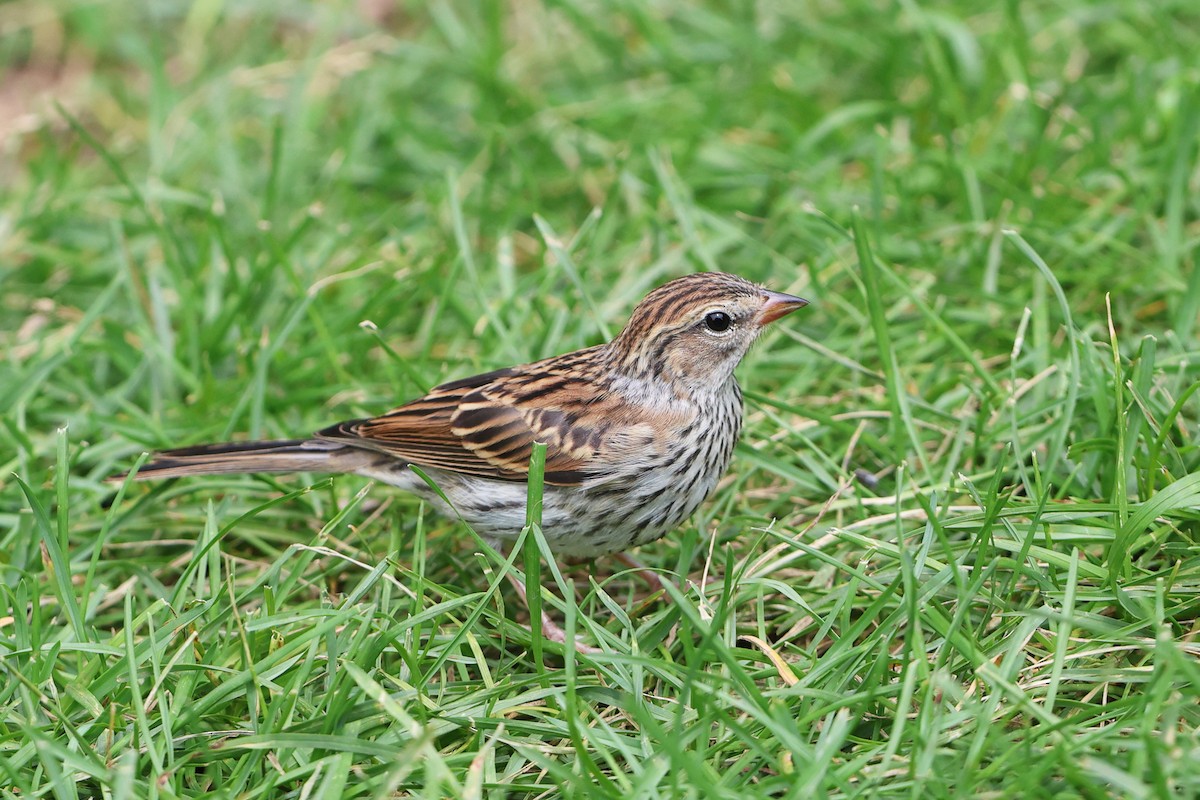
[109,439,371,482]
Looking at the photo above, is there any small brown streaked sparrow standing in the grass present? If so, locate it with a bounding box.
[114,272,808,642]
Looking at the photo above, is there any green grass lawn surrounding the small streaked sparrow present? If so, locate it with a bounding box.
[0,0,1200,799]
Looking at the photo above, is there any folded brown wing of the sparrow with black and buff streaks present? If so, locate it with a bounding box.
[317,350,662,486]
